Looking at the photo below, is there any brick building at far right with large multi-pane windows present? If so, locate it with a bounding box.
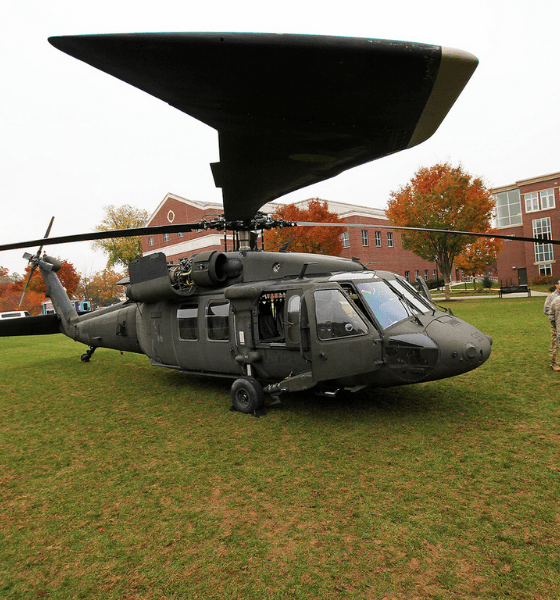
[492,173,560,284]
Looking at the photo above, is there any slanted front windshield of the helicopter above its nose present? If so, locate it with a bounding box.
[356,279,430,329]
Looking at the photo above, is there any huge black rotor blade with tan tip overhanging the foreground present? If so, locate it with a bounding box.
[49,33,478,221]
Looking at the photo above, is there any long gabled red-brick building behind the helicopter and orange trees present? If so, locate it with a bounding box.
[142,194,442,282]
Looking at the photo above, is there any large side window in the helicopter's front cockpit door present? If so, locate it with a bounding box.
[314,290,368,340]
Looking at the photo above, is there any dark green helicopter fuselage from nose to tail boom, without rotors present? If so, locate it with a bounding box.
[57,253,491,392]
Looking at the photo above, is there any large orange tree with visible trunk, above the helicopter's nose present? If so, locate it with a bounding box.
[386,163,494,298]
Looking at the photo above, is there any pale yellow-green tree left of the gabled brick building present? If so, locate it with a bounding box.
[93,204,149,269]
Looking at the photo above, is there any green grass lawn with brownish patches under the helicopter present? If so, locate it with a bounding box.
[0,298,560,600]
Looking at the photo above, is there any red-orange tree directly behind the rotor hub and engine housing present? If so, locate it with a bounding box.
[264,198,347,255]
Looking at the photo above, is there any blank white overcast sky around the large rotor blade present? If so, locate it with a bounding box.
[0,0,560,274]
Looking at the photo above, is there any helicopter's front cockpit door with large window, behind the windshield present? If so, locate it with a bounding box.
[301,284,382,381]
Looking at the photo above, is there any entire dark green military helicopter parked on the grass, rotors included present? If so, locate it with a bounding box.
[0,33,534,414]
